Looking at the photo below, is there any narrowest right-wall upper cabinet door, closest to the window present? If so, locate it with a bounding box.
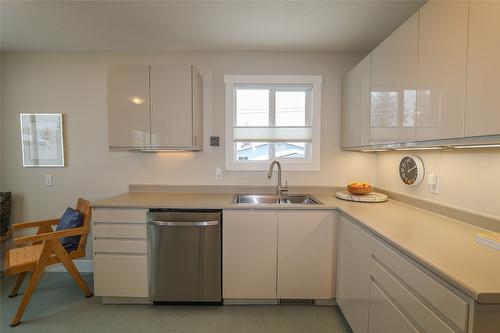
[341,54,372,148]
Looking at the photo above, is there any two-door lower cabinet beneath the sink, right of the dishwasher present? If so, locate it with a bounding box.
[222,210,336,299]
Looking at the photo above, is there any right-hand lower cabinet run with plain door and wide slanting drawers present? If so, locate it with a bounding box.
[337,217,475,333]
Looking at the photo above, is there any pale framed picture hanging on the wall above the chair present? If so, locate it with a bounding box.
[21,113,64,167]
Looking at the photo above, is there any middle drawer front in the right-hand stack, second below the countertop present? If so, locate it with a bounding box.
[371,260,454,333]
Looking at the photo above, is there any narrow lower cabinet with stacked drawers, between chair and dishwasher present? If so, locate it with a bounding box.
[92,209,149,298]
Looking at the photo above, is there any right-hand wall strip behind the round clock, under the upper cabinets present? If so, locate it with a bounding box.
[376,149,500,218]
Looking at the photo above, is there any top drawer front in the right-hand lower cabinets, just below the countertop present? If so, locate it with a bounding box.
[372,239,469,332]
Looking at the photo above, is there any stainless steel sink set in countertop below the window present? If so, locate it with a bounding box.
[232,194,323,205]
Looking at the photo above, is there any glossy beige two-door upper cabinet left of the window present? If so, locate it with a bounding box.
[108,65,203,151]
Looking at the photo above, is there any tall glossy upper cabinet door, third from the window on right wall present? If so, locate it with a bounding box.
[417,1,470,140]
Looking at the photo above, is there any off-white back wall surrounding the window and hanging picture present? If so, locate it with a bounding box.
[2,52,375,226]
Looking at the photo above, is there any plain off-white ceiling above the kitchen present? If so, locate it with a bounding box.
[0,0,424,52]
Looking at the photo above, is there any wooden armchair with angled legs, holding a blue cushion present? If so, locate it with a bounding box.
[5,198,92,326]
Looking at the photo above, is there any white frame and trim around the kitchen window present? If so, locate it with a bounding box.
[224,75,323,171]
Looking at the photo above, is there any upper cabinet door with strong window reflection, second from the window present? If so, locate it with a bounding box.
[370,13,418,143]
